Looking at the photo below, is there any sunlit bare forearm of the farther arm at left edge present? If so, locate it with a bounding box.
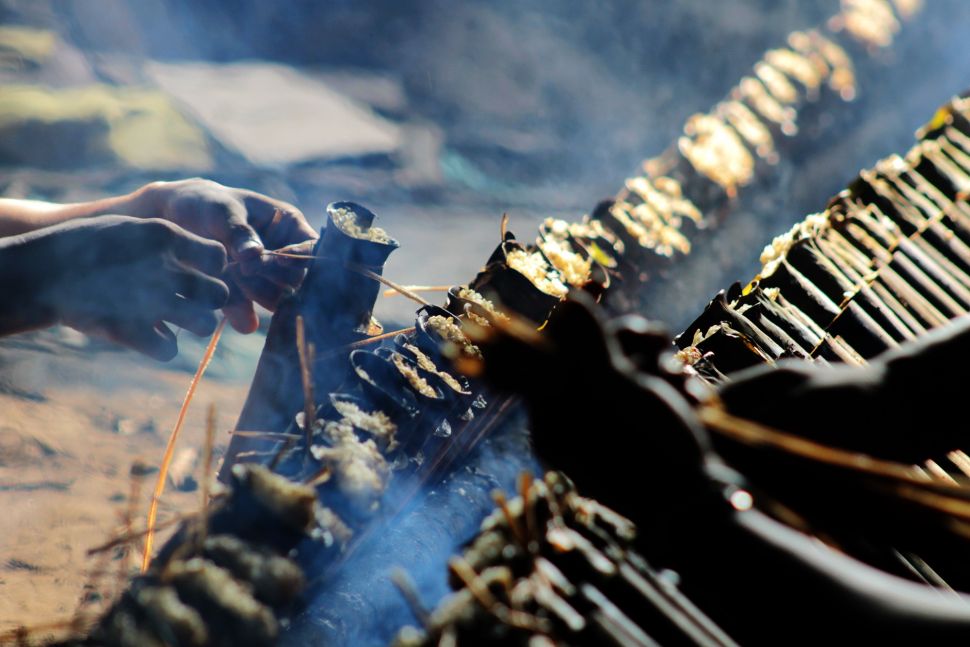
[0,184,153,237]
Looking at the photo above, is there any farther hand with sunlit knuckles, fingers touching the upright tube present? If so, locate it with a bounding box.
[129,178,318,333]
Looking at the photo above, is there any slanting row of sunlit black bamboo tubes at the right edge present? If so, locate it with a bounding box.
[678,93,970,382]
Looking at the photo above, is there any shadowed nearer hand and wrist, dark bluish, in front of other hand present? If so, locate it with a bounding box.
[0,216,229,361]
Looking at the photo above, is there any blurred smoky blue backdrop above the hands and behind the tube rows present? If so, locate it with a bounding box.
[0,0,970,327]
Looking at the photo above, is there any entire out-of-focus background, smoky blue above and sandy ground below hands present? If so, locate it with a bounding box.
[0,0,970,628]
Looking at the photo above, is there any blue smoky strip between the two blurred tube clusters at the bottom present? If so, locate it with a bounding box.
[281,409,541,647]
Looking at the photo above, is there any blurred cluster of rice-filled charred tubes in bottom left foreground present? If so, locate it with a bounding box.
[62,465,328,647]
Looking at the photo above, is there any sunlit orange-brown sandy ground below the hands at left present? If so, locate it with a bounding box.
[0,333,257,633]
